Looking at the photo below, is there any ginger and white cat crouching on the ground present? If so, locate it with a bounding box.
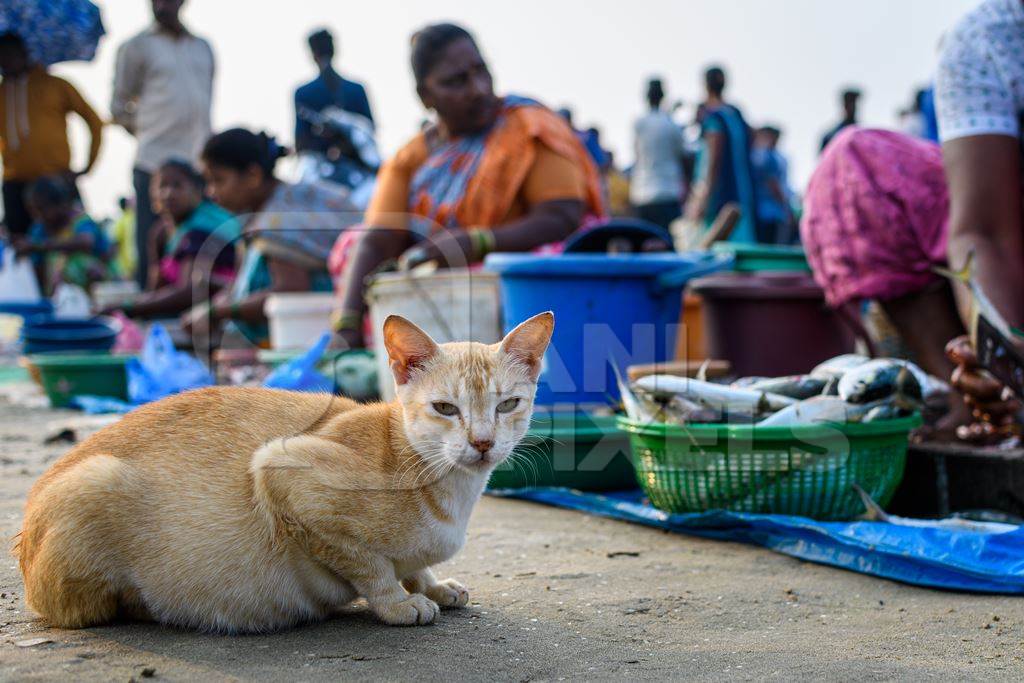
[14,312,554,632]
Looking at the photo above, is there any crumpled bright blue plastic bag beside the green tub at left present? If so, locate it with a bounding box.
[125,323,214,404]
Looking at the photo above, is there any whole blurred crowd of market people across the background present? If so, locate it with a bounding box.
[0,0,1024,436]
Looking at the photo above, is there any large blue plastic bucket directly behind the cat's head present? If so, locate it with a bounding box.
[484,252,732,411]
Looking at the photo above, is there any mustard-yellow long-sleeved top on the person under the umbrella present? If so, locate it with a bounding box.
[0,67,103,180]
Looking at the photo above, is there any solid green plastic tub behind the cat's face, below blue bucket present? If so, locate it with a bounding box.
[487,413,636,490]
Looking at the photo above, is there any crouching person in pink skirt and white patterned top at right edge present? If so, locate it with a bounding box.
[801,0,1024,435]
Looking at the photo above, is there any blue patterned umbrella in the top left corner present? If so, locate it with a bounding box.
[0,0,105,66]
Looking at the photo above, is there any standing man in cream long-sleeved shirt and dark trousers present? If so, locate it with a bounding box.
[111,0,214,287]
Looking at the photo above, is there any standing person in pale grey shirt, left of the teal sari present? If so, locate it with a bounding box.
[630,79,683,229]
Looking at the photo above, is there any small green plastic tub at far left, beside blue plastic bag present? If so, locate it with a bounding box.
[29,352,134,408]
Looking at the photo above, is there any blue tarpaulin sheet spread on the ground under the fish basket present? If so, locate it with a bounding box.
[492,487,1024,594]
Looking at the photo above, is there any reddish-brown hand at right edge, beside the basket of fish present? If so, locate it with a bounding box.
[946,336,1022,443]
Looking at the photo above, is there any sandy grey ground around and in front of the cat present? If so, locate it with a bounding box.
[0,387,1024,681]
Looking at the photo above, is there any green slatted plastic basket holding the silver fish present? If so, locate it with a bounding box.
[618,416,921,519]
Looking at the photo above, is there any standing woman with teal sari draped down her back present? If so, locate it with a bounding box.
[683,67,757,243]
